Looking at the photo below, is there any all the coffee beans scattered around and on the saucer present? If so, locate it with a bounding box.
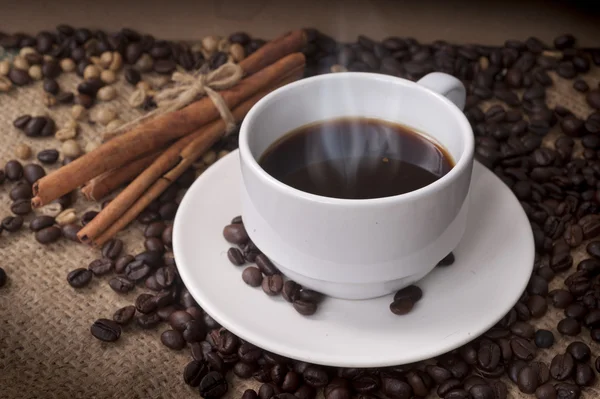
[0,25,600,399]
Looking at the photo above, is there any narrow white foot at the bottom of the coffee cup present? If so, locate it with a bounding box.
[273,262,435,300]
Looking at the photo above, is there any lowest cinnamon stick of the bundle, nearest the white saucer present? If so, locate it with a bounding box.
[78,68,303,245]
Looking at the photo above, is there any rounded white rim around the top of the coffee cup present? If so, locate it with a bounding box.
[238,72,475,207]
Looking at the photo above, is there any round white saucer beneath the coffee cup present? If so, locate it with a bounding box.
[173,151,534,367]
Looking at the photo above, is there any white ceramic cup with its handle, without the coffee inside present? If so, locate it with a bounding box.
[239,73,474,299]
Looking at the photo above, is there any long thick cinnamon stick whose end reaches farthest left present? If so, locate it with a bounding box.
[31,53,305,208]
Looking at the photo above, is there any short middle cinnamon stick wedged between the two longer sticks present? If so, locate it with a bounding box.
[81,152,160,201]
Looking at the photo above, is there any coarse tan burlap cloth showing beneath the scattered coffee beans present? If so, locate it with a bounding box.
[0,54,600,399]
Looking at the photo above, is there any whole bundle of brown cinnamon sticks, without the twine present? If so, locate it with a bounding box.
[32,30,306,246]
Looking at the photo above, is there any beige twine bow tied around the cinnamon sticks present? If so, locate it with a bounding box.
[154,62,244,133]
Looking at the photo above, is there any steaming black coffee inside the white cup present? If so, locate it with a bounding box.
[259,118,453,199]
